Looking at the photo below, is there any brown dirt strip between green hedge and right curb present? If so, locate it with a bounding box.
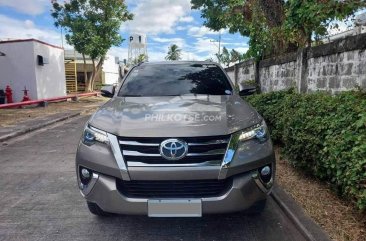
[276,148,366,241]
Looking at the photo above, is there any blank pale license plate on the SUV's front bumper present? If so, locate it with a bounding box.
[147,199,202,217]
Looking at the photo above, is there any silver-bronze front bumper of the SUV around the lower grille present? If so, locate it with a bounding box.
[76,131,275,215]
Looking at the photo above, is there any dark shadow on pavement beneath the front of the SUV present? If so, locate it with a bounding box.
[78,200,303,240]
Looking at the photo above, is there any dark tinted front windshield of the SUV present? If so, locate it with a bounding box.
[118,64,232,96]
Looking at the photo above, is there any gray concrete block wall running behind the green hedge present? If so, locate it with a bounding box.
[226,34,366,94]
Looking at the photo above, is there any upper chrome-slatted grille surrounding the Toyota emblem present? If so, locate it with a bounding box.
[118,135,230,166]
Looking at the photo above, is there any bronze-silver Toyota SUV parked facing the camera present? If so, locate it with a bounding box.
[76,61,275,217]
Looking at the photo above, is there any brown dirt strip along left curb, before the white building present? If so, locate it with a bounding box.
[0,96,108,127]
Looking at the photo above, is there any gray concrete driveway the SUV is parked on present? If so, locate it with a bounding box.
[0,117,305,241]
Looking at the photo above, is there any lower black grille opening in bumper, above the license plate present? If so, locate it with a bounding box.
[116,178,233,198]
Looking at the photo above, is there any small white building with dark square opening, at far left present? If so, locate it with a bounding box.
[0,39,66,102]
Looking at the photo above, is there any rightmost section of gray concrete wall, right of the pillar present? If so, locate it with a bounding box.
[306,38,366,93]
